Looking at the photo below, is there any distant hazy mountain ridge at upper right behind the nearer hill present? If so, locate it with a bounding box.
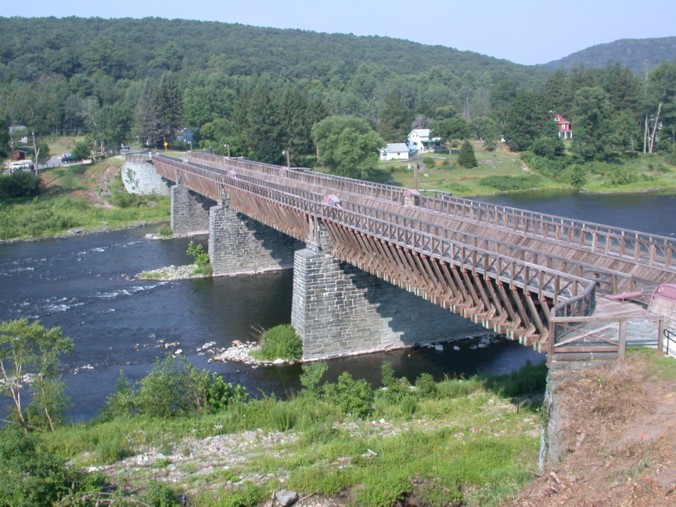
[539,37,676,74]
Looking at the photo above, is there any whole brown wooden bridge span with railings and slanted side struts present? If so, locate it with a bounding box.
[145,153,676,357]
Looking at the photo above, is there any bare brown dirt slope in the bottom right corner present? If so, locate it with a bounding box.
[510,354,676,507]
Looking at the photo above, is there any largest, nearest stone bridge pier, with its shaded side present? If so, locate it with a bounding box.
[291,249,476,360]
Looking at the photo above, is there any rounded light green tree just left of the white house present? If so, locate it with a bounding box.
[312,116,385,178]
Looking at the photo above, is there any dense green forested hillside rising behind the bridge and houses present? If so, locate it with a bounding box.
[0,17,676,176]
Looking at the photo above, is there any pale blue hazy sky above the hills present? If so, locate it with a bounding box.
[0,0,676,64]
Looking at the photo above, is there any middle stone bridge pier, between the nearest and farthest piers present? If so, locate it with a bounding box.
[209,197,303,276]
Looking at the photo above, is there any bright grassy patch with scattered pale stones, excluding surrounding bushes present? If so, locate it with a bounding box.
[37,366,546,507]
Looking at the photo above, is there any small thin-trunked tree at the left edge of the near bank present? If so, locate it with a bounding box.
[0,319,73,431]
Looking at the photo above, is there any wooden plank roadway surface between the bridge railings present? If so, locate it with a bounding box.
[186,154,676,297]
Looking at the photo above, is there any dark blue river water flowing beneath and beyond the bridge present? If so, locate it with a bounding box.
[0,190,676,421]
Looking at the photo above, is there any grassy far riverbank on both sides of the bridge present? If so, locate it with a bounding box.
[0,150,676,242]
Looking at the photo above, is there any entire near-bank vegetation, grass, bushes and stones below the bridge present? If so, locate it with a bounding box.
[0,320,546,506]
